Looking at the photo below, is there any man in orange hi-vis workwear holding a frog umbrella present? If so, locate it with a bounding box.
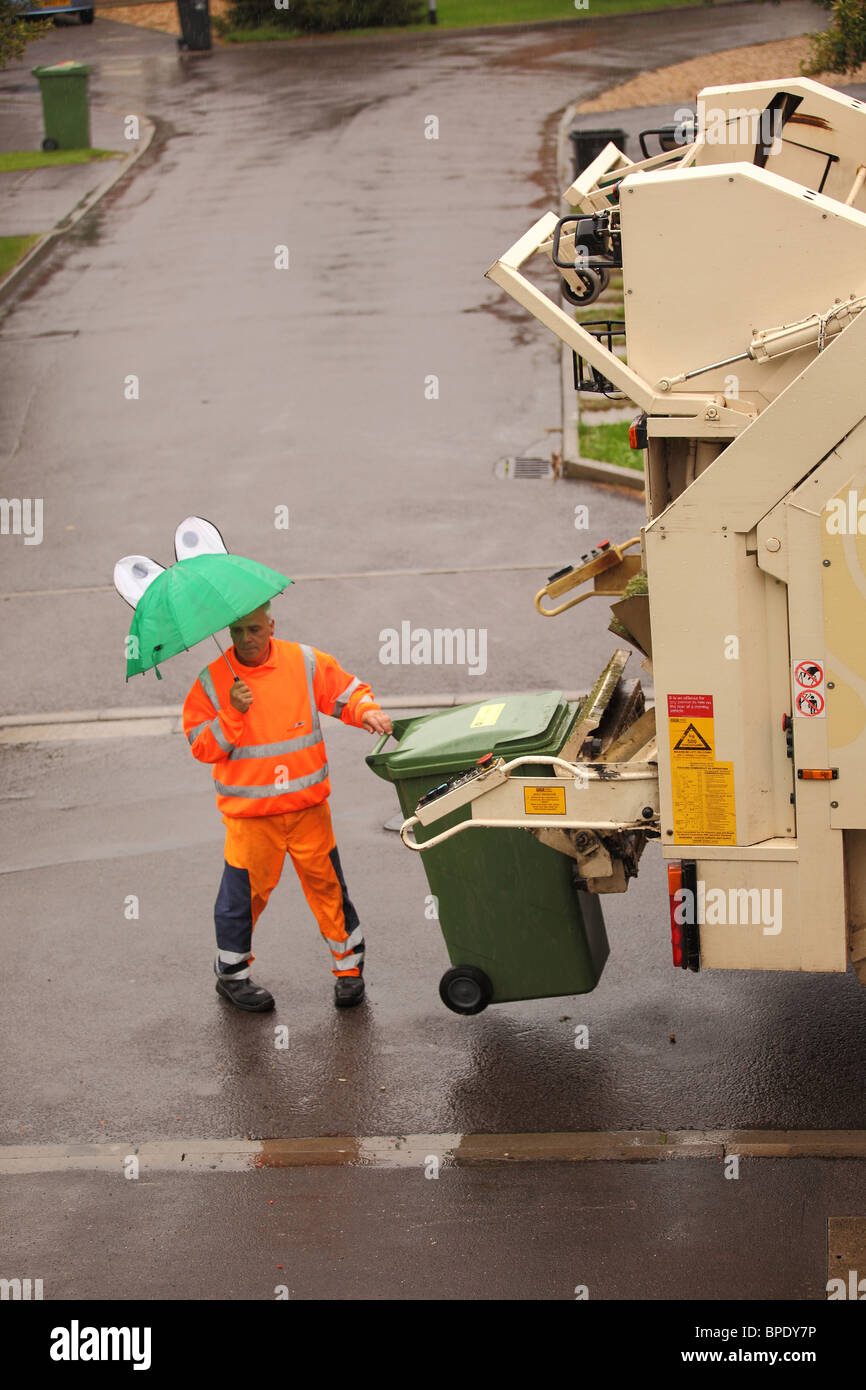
[183,603,391,1013]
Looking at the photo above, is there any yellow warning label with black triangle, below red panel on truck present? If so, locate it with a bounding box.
[667,717,737,845]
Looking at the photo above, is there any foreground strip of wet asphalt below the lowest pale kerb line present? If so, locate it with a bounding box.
[4,1159,863,1295]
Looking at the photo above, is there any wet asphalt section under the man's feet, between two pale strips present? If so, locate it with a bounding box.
[1,724,866,1144]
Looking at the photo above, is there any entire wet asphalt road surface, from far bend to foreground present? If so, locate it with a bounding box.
[0,3,866,1298]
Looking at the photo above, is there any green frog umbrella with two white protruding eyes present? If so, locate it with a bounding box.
[114,517,292,680]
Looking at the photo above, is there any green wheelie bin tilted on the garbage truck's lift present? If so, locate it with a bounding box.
[367,691,607,1013]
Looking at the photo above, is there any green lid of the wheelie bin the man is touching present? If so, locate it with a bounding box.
[367,691,577,781]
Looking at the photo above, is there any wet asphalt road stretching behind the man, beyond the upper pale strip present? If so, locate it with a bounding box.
[0,0,816,713]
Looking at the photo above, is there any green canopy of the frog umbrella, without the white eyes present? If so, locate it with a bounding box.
[126,555,292,680]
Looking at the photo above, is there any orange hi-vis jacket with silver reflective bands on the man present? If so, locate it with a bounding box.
[183,638,379,816]
